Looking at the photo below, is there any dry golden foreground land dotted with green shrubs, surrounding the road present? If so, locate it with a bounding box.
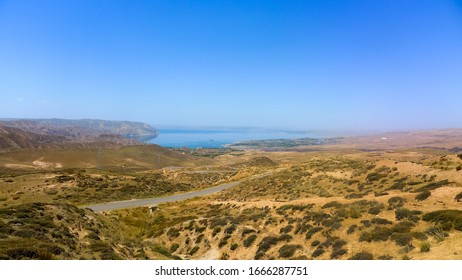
[0,131,462,260]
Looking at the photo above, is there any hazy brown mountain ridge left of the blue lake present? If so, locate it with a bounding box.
[0,119,158,149]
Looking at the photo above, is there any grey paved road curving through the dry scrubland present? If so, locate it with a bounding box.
[82,173,270,211]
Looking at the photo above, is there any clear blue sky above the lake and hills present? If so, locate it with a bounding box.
[0,0,462,130]
